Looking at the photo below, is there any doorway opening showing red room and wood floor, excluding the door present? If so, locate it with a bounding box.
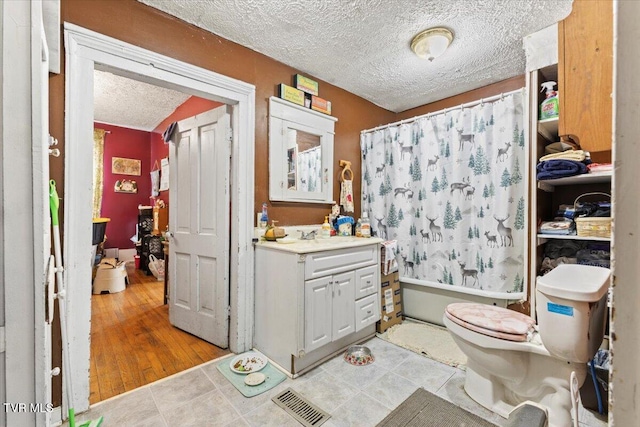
[89,70,229,404]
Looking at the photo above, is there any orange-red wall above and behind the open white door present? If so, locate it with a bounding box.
[150,96,223,202]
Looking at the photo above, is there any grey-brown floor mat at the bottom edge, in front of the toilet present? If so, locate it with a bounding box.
[377,388,495,427]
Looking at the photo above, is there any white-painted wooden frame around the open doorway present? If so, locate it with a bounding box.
[63,22,255,412]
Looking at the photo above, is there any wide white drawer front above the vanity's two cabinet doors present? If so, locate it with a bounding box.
[304,244,379,280]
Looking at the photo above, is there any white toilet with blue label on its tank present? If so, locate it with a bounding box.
[443,264,610,427]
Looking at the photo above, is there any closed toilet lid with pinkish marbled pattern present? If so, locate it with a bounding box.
[445,303,535,341]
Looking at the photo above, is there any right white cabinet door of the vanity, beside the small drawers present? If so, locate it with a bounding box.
[331,271,356,341]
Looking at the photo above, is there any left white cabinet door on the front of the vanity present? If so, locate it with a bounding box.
[304,276,332,353]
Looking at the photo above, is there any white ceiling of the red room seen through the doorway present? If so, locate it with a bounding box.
[93,70,190,132]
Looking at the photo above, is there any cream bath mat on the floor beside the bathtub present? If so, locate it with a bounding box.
[380,320,467,369]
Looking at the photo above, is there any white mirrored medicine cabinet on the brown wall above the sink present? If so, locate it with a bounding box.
[269,97,338,203]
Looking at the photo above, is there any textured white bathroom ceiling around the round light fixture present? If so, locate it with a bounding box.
[138,0,571,112]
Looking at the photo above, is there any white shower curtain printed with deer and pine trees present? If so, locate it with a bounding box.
[360,91,527,298]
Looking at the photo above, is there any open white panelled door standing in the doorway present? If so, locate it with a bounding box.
[168,106,231,348]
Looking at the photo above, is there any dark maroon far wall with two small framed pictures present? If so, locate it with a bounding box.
[94,123,151,249]
